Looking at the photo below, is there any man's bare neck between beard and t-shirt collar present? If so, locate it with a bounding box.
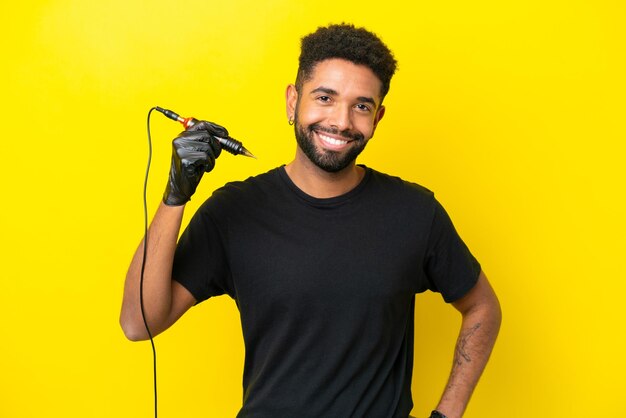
[285,149,365,199]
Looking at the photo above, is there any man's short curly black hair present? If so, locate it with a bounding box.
[296,23,397,98]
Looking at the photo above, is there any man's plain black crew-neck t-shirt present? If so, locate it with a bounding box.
[173,167,480,418]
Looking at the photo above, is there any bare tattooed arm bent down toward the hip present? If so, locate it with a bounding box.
[437,271,502,418]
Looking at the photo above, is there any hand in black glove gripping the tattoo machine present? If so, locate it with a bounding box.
[163,121,228,206]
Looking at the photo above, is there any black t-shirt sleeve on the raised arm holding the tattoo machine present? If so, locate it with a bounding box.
[172,199,233,303]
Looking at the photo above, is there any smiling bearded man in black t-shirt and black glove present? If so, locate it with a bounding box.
[121,24,500,418]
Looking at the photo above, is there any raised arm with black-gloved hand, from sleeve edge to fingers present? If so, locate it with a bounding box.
[120,122,228,341]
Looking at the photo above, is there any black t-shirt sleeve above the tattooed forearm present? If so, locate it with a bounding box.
[424,201,481,303]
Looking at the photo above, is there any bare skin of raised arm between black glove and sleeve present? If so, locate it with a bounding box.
[120,203,196,341]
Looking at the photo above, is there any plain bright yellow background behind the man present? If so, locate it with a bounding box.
[0,0,626,418]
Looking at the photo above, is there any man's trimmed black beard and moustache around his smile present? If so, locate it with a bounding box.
[294,117,366,173]
